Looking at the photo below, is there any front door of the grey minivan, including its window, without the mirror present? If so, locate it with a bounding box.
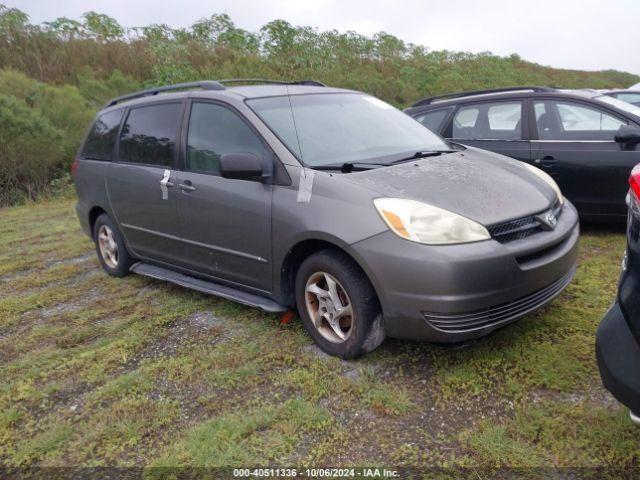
[176,101,273,291]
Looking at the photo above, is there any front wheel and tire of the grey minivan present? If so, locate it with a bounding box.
[295,249,385,359]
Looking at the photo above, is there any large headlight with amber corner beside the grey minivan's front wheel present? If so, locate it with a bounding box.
[373,198,491,245]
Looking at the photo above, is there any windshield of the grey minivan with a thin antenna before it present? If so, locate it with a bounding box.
[247,93,451,167]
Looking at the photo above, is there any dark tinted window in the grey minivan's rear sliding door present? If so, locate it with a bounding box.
[119,103,181,167]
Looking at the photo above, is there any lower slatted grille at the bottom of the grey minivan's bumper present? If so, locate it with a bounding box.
[423,267,575,333]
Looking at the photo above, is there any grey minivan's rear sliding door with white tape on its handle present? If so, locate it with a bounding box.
[107,103,182,263]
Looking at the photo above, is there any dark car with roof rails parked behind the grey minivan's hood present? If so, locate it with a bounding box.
[405,87,640,221]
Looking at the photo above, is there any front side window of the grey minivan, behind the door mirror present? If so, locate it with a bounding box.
[187,103,265,174]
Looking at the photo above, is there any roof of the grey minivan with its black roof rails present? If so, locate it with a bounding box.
[101,82,361,113]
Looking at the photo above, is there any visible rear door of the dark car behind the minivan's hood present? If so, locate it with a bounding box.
[446,99,531,162]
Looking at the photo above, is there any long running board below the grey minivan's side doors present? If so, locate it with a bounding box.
[131,262,288,313]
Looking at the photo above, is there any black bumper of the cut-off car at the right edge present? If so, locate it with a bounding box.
[596,302,640,419]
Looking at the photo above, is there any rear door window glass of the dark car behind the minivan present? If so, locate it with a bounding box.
[452,102,522,140]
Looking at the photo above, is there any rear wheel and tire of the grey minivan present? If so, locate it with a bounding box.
[93,213,134,277]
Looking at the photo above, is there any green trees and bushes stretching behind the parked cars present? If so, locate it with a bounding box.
[0,4,640,204]
